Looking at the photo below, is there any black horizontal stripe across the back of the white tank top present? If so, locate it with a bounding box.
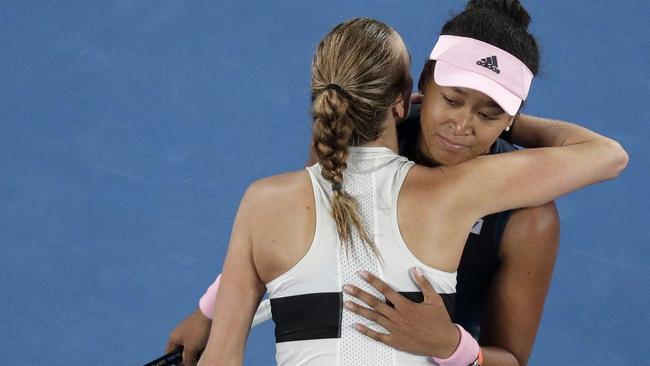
[271,292,455,343]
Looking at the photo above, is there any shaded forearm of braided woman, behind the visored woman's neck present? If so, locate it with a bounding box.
[511,114,607,148]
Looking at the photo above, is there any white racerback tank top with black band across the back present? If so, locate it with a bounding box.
[266,147,456,366]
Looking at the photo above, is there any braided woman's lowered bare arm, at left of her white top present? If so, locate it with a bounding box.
[199,188,265,366]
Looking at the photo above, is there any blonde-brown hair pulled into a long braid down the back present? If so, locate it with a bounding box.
[311,18,410,255]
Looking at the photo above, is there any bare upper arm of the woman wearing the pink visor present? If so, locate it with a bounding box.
[480,203,560,366]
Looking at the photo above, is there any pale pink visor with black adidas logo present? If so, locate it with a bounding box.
[429,36,533,116]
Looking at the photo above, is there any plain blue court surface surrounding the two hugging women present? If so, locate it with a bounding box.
[0,0,650,365]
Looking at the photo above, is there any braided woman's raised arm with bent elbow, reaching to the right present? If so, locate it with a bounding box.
[446,122,628,222]
